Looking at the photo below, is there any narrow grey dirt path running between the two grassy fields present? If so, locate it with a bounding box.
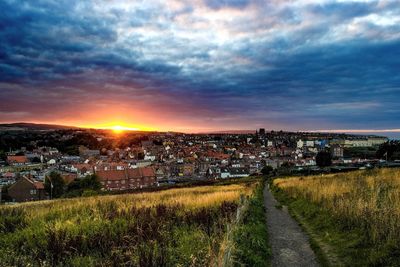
[264,186,319,267]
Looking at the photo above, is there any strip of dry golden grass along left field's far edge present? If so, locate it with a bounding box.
[16,183,256,222]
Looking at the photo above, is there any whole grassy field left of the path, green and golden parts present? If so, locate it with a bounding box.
[0,182,256,266]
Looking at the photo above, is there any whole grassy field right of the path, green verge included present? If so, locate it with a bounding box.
[273,169,400,266]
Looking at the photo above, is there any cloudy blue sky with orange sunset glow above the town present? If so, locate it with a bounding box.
[0,0,400,135]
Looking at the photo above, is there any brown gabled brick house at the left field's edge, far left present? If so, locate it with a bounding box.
[8,176,46,202]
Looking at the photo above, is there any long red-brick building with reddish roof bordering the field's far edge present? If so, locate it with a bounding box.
[96,167,157,191]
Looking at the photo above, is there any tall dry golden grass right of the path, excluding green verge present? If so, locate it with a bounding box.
[274,169,400,245]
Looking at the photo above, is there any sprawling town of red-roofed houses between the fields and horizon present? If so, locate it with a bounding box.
[0,129,399,203]
